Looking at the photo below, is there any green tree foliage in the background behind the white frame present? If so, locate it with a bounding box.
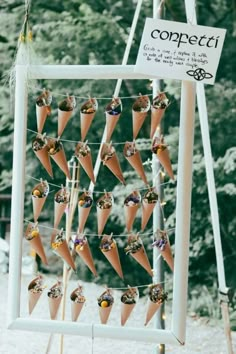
[0,0,236,312]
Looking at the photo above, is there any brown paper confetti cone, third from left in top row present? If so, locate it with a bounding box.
[80,98,98,141]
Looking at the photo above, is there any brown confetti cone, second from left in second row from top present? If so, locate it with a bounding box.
[47,138,71,179]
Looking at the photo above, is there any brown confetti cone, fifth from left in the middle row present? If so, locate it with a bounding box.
[124,191,141,232]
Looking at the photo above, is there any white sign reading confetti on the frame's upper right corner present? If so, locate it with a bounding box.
[135,18,226,84]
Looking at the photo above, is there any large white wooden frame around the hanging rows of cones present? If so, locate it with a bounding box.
[8,65,195,344]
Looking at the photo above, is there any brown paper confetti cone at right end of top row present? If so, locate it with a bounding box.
[150,92,169,139]
